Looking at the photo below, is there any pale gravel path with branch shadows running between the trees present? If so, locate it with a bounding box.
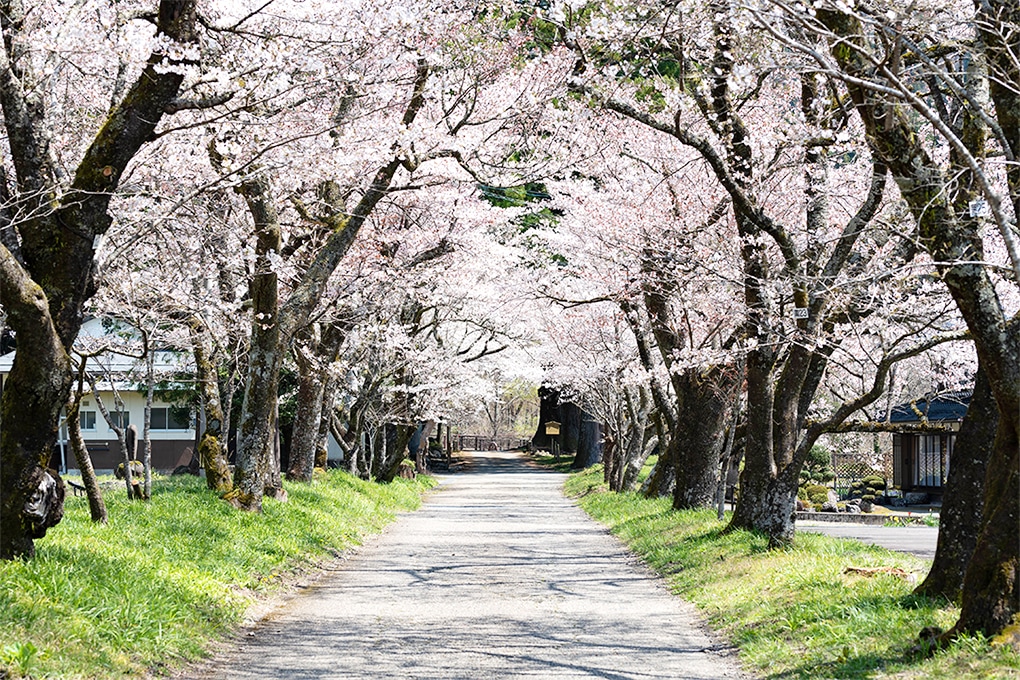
[189,452,746,679]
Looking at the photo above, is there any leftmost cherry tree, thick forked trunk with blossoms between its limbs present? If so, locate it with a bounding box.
[0,2,199,559]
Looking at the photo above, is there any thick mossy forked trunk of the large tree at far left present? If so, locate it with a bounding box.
[0,0,197,560]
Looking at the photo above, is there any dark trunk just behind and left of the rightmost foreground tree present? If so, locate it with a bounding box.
[914,366,999,601]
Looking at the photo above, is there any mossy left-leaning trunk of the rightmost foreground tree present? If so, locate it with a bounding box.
[818,10,1020,648]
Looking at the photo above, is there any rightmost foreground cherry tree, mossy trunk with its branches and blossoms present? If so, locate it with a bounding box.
[758,3,1020,645]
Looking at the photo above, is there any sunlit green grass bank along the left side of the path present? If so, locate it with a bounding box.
[0,472,435,678]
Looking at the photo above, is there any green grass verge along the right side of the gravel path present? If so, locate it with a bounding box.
[566,466,1020,680]
